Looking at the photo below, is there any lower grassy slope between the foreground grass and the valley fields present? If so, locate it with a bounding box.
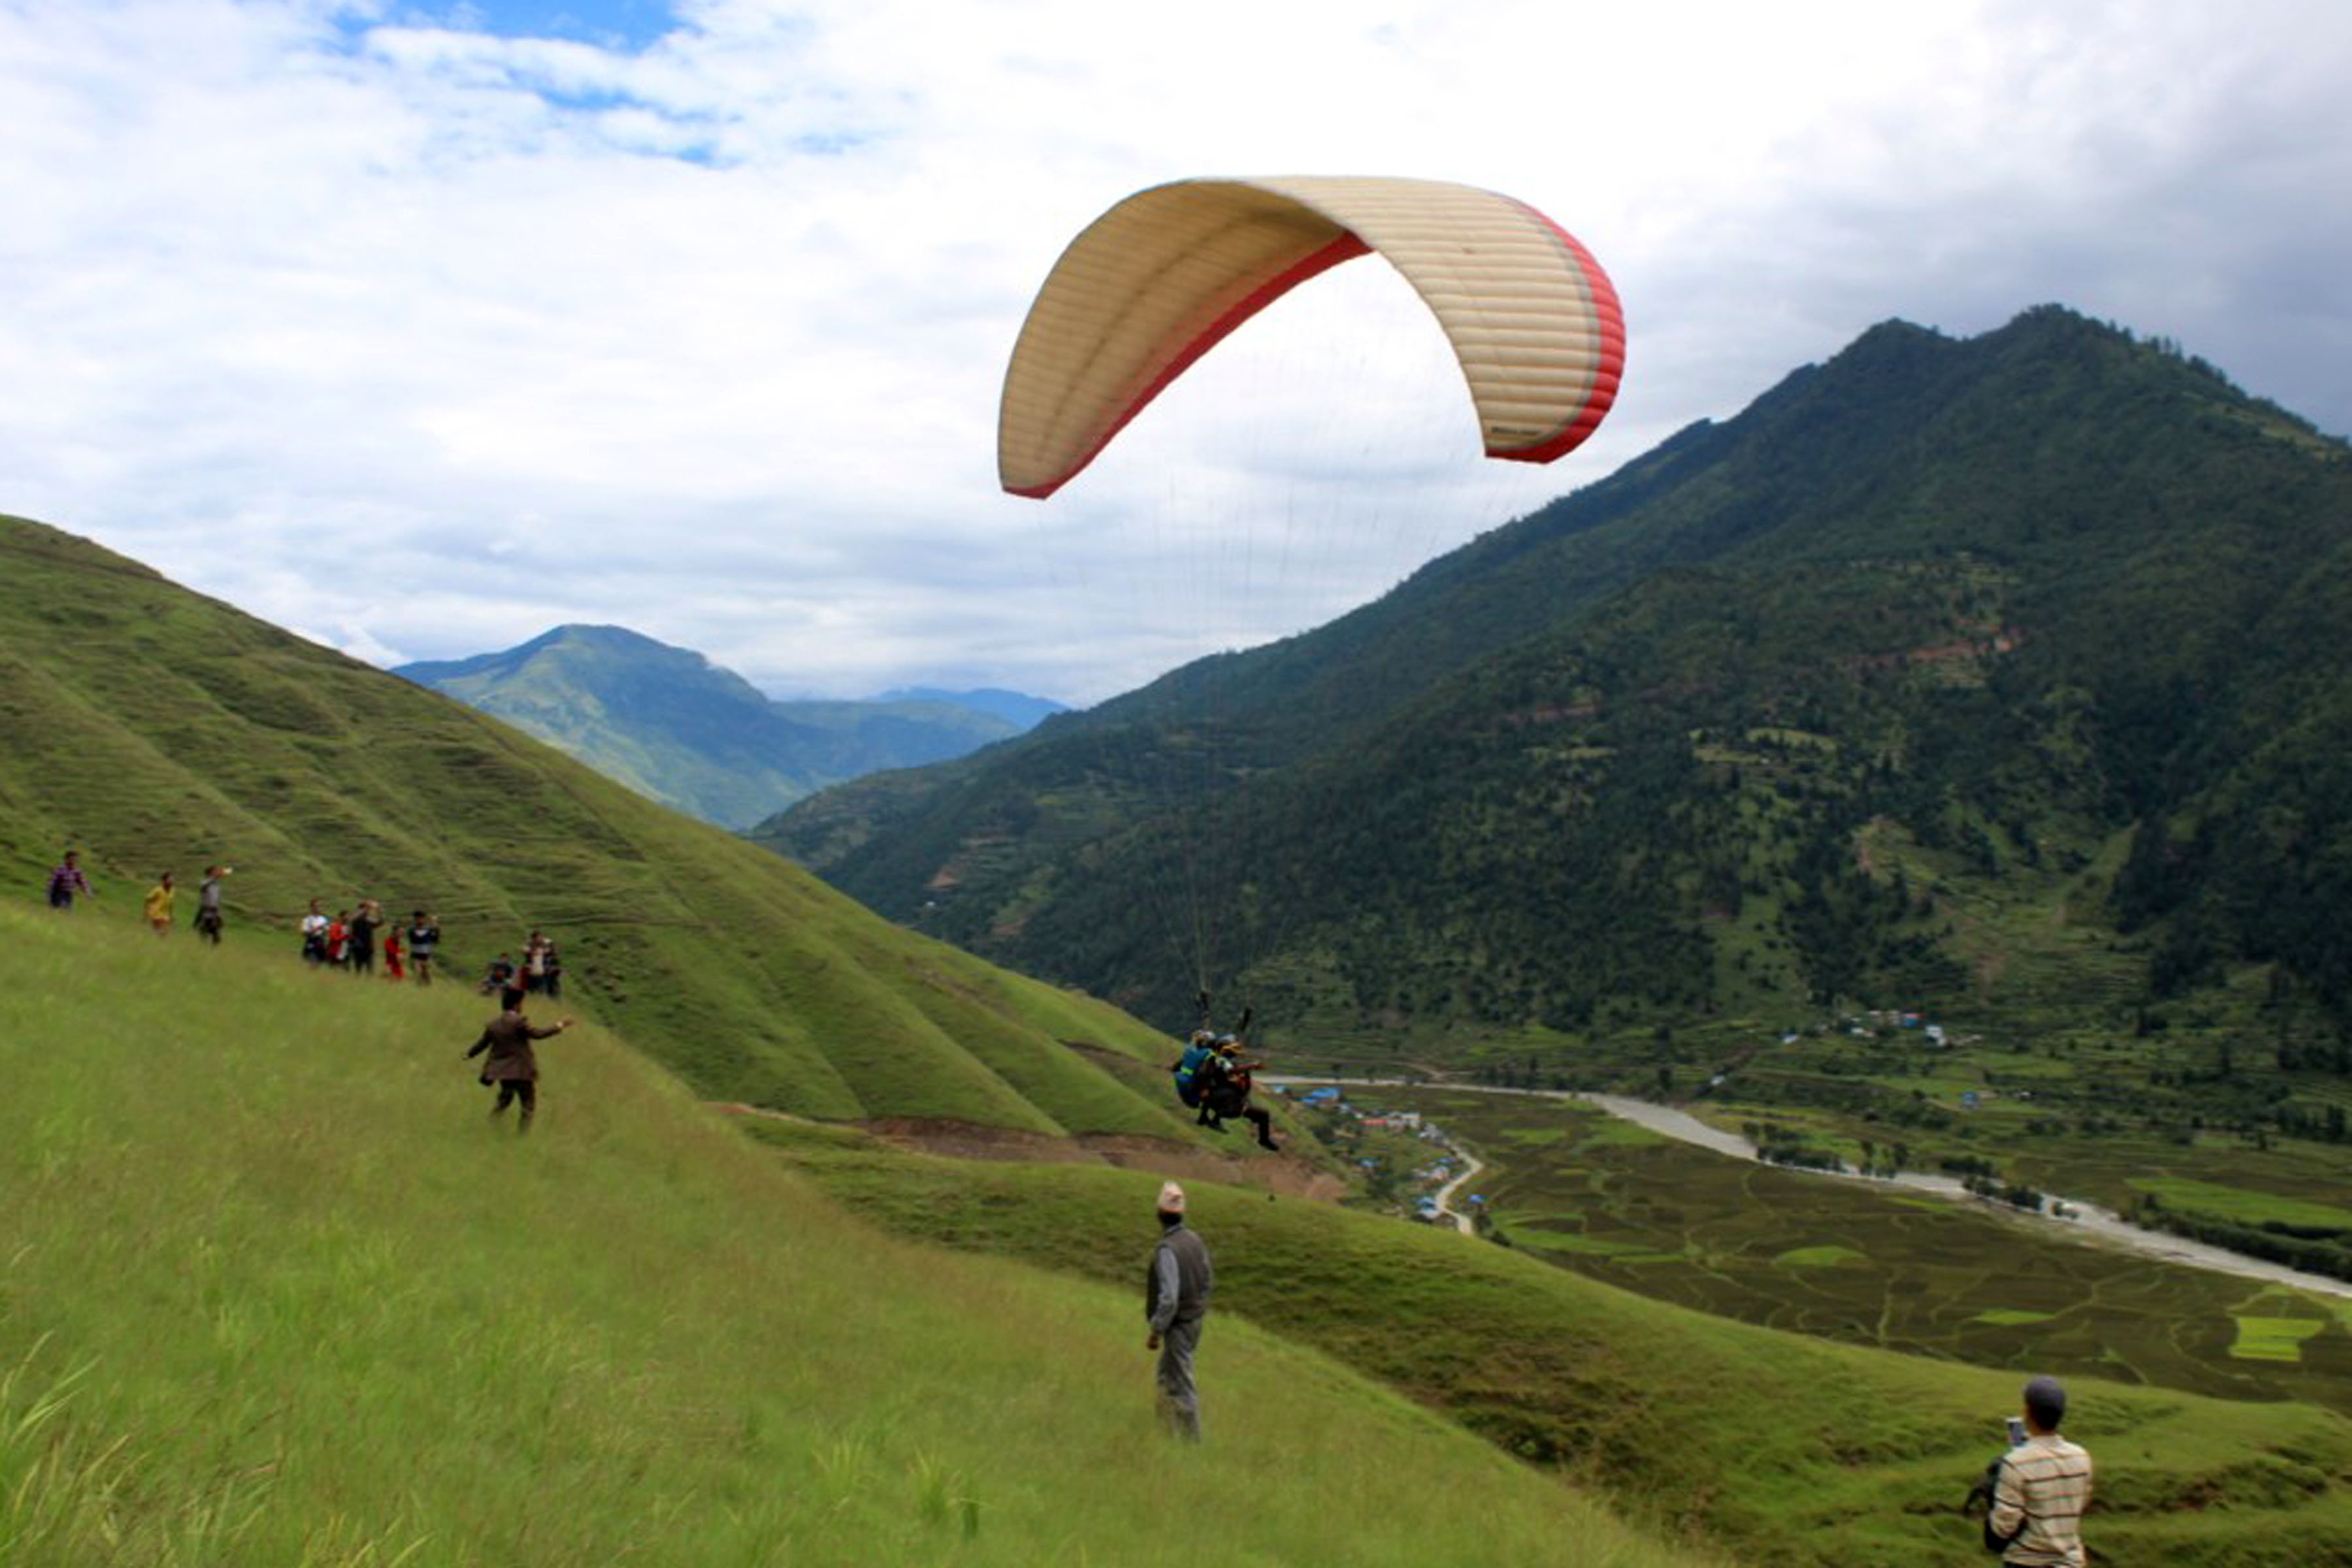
[769,1128,2352,1568]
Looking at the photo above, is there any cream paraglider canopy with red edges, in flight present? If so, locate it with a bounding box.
[997,176,1625,498]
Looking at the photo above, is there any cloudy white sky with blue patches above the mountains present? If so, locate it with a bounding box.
[0,0,2352,700]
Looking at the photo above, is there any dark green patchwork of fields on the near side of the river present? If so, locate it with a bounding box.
[1335,1091,2352,1413]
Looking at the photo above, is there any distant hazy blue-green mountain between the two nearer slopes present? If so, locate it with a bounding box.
[393,625,1056,828]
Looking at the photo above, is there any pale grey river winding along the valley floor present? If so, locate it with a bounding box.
[1261,1077,2352,1298]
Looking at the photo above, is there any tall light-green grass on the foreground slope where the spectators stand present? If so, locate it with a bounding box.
[0,907,1698,1568]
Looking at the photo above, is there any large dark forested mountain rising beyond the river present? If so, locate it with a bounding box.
[757,308,2352,1053]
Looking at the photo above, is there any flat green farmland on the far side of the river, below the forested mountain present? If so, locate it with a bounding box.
[1390,1001,2352,1298]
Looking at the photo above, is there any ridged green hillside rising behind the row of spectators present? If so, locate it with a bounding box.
[0,517,1241,1138]
